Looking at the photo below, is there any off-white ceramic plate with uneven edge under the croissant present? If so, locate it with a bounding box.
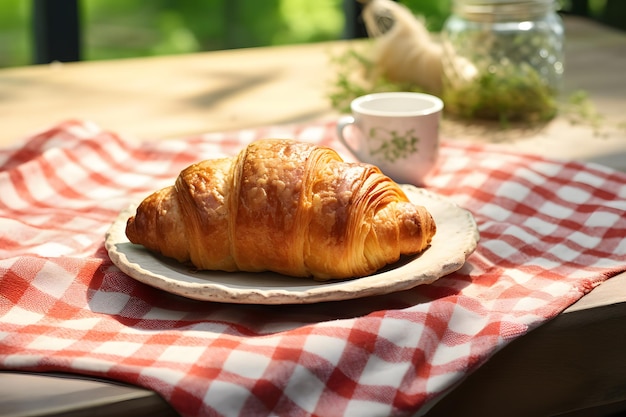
[105,185,479,304]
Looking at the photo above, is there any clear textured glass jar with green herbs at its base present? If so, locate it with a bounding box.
[442,0,564,122]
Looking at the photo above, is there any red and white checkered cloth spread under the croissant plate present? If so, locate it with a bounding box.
[0,121,626,416]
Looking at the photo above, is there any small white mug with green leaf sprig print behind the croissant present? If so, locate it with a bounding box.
[337,92,443,185]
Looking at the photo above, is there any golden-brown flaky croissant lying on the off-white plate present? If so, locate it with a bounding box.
[126,139,436,281]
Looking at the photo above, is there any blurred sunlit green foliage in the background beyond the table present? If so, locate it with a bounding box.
[0,0,606,67]
